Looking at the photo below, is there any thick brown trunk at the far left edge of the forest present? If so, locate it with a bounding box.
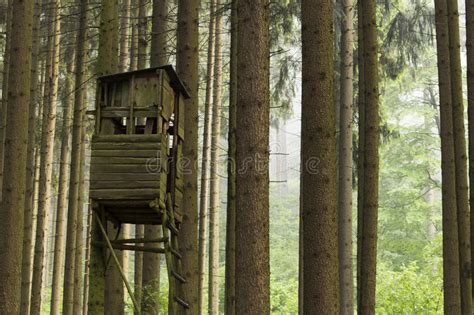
[0,0,34,314]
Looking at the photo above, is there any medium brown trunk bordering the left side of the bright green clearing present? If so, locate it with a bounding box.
[360,0,380,314]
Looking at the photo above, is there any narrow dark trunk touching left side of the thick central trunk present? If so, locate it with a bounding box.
[225,0,237,315]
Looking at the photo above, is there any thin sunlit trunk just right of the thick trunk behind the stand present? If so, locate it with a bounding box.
[198,0,215,314]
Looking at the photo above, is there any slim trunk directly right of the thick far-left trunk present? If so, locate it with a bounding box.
[20,0,41,314]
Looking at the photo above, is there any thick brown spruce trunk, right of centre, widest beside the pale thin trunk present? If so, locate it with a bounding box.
[302,0,339,314]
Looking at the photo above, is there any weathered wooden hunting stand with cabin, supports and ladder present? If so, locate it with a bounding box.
[90,66,189,314]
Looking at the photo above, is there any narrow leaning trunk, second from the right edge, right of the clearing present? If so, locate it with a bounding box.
[448,0,472,314]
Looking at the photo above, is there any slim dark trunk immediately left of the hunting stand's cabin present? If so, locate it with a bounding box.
[63,0,89,315]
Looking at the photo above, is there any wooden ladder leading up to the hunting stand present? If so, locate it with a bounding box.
[161,193,189,315]
